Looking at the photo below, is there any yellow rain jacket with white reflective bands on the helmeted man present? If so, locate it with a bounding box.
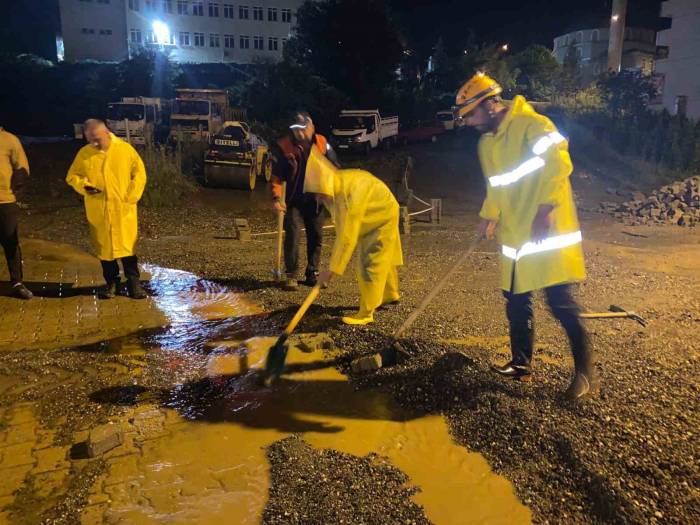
[479,96,586,293]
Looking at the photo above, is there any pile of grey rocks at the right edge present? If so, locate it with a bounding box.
[600,176,700,226]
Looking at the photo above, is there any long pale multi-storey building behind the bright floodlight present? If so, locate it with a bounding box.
[59,0,304,64]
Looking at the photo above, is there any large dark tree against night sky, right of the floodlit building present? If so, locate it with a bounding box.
[287,0,402,106]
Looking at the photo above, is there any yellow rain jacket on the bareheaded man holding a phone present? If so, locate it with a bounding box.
[66,135,146,261]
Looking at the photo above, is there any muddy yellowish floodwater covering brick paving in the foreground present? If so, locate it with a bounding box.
[0,239,530,524]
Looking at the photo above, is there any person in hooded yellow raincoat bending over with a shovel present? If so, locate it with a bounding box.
[304,145,403,325]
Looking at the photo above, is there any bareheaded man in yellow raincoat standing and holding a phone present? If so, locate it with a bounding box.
[66,119,146,299]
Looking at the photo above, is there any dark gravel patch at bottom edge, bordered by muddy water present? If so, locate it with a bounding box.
[262,436,430,525]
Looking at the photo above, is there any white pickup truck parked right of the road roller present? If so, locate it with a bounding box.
[331,109,399,153]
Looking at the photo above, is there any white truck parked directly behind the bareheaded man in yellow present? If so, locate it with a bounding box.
[107,97,164,145]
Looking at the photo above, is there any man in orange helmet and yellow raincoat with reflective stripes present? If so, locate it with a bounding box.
[456,73,597,400]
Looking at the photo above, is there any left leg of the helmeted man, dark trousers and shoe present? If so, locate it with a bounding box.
[492,292,535,379]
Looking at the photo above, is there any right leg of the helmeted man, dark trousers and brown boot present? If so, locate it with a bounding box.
[545,284,597,399]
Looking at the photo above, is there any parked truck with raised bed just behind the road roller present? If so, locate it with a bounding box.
[170,89,246,141]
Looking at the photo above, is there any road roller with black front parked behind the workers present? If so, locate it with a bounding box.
[204,121,272,191]
